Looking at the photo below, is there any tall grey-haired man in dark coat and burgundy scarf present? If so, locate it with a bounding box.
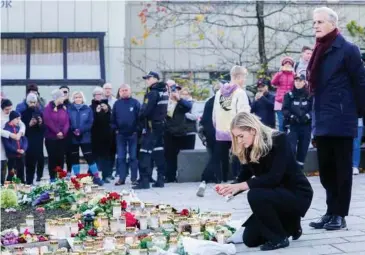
[307,7,365,230]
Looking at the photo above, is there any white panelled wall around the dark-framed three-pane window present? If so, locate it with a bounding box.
[1,0,126,103]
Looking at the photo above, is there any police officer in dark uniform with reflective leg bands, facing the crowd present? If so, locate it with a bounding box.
[133,71,169,189]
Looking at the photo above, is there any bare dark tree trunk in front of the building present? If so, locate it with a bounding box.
[256,1,268,71]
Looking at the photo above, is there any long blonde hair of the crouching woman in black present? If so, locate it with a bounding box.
[231,112,275,164]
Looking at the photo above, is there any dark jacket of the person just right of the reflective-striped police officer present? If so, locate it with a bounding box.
[165,99,193,136]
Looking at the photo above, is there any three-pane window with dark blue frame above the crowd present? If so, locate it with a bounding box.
[1,32,105,85]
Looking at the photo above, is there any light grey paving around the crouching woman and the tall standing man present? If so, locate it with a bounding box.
[42,166,365,255]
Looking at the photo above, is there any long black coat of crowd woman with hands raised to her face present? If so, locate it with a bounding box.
[90,99,113,157]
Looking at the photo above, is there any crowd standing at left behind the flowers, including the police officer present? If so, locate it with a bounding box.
[1,72,197,188]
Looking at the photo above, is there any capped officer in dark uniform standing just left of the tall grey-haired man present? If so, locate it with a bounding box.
[282,75,313,168]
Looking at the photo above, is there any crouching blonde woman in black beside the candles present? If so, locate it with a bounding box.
[216,112,313,250]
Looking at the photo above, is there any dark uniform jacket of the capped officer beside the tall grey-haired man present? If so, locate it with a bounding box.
[282,88,313,126]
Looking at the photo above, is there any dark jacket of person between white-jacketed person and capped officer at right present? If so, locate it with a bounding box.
[251,92,275,128]
